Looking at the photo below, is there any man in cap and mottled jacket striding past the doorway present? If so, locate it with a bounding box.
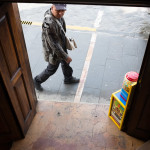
[34,4,79,91]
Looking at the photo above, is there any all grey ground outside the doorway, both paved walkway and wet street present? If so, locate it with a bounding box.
[19,4,150,104]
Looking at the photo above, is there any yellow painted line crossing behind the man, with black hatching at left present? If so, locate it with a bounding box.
[21,21,96,31]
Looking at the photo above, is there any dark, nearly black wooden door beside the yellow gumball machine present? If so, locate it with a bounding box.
[126,35,150,140]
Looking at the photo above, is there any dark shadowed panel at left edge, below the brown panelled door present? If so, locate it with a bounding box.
[0,74,21,142]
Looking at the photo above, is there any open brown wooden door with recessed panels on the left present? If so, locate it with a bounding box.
[0,3,36,136]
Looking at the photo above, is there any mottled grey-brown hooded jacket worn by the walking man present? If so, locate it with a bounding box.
[42,9,68,64]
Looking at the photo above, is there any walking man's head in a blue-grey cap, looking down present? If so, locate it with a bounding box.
[51,4,66,19]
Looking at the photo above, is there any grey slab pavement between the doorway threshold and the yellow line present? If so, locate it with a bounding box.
[19,3,147,104]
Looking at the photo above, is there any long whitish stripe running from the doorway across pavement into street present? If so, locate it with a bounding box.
[74,11,103,103]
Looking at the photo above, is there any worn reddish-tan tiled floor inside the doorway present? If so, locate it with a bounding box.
[11,101,143,150]
